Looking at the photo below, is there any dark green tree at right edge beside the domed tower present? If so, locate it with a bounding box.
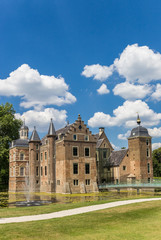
[152,148,161,177]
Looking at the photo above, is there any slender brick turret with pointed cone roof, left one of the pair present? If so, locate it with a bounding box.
[29,127,40,192]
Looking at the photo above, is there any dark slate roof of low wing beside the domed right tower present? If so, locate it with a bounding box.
[108,149,128,167]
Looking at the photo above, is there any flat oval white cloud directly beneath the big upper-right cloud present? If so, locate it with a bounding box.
[113,82,152,100]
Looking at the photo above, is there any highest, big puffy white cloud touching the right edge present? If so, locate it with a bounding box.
[114,44,161,83]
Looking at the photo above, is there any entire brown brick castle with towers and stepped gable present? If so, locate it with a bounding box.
[9,115,153,193]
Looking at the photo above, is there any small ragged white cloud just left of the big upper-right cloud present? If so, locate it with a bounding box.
[82,64,113,81]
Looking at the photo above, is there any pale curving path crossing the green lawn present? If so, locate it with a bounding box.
[0,198,161,224]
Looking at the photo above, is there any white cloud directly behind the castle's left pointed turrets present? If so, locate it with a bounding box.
[15,108,67,132]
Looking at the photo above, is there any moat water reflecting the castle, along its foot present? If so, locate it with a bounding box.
[0,191,160,207]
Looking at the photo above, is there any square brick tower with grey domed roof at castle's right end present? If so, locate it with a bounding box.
[128,115,153,182]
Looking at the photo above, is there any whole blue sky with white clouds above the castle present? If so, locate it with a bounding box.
[0,0,161,149]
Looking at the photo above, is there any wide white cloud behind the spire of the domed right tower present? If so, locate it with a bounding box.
[88,100,161,128]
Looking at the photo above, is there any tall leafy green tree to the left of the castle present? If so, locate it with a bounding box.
[0,103,22,186]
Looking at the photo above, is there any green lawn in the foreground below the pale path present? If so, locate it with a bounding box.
[0,201,161,240]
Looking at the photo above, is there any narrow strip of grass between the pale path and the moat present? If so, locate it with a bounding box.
[0,193,160,218]
